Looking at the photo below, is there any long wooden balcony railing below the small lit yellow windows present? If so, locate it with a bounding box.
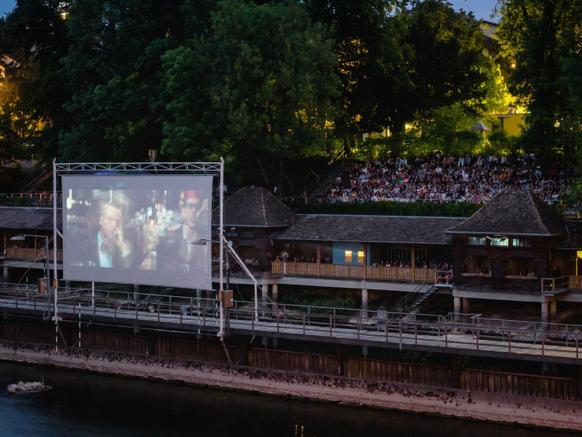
[271,261,438,284]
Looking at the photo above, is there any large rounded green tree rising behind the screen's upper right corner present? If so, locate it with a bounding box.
[163,1,337,185]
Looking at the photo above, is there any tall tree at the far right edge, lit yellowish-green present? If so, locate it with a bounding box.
[499,0,582,164]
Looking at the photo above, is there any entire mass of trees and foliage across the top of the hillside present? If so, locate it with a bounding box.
[0,0,582,192]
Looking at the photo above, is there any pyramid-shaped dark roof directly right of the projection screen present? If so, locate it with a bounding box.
[213,187,295,228]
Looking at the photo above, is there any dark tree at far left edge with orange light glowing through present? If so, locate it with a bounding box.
[1,0,68,158]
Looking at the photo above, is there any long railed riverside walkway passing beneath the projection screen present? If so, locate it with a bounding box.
[0,284,582,364]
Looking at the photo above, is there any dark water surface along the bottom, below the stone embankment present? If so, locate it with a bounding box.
[0,363,573,437]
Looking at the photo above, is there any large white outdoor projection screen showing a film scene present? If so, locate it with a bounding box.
[62,175,212,290]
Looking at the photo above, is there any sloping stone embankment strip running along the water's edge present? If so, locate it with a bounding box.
[0,344,582,431]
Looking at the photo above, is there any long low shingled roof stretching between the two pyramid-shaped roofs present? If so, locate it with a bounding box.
[271,214,463,245]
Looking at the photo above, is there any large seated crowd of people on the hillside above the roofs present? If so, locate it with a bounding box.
[327,153,573,203]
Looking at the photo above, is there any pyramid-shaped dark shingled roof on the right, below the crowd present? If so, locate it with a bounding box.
[447,191,566,237]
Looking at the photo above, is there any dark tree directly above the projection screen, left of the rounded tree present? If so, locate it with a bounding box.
[60,0,211,160]
